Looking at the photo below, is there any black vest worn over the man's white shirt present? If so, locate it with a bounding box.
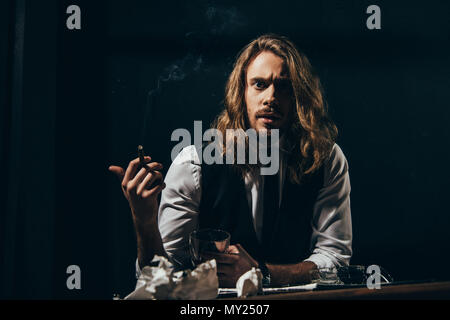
[199,156,324,264]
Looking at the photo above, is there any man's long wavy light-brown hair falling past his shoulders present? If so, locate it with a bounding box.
[212,34,338,184]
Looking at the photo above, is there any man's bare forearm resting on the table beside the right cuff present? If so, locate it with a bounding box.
[267,261,317,286]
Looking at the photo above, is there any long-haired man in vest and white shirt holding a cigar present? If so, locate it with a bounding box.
[110,35,352,287]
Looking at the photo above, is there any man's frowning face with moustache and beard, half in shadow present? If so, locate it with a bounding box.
[245,51,294,131]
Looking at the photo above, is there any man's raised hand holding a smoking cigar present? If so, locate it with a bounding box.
[109,157,165,225]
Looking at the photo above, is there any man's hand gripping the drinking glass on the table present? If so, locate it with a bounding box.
[202,244,258,288]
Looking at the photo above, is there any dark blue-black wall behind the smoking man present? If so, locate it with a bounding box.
[0,0,450,299]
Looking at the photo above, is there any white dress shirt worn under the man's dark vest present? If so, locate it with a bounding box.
[150,144,352,274]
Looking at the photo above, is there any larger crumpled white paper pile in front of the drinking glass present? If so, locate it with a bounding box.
[125,256,219,300]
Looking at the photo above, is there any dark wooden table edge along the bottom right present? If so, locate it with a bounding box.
[227,281,450,300]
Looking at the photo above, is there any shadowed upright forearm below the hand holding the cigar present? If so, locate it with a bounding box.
[134,214,167,268]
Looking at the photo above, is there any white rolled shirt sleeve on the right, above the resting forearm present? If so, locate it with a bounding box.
[305,144,352,268]
